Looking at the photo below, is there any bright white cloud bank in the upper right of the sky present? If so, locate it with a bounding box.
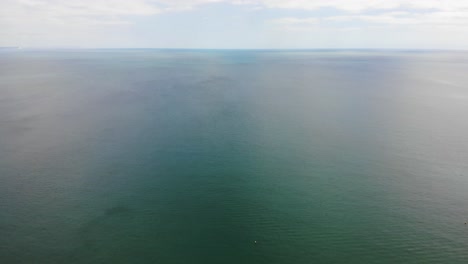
[264,0,468,31]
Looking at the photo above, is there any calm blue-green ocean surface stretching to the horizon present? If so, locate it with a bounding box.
[0,49,468,264]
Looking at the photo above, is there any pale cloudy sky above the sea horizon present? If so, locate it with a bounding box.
[0,0,468,49]
